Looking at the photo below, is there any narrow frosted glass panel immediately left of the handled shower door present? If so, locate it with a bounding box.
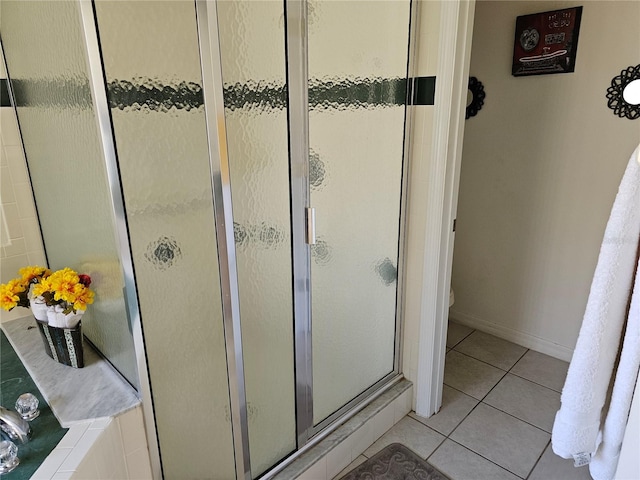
[218,1,296,477]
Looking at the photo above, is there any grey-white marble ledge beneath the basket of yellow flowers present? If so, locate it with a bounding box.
[2,316,141,428]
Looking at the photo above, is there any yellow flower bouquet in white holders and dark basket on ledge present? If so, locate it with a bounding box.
[0,266,94,368]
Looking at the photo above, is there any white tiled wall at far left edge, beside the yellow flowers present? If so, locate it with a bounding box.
[0,45,46,322]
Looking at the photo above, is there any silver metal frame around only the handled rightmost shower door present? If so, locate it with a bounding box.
[285,0,417,449]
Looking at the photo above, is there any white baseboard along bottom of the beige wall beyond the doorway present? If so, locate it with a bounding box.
[449,309,573,362]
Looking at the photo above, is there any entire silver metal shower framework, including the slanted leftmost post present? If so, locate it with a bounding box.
[71,0,417,480]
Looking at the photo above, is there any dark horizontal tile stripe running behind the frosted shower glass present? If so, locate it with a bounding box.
[7,77,435,112]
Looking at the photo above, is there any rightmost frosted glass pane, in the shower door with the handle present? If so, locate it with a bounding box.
[309,0,409,424]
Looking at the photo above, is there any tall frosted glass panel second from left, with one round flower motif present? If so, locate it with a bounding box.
[96,1,235,479]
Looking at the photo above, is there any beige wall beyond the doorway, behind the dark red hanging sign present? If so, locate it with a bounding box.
[451,0,640,360]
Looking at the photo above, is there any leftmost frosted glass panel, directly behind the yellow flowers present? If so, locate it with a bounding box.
[0,0,138,386]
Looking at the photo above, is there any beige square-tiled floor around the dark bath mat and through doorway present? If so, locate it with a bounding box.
[336,322,591,480]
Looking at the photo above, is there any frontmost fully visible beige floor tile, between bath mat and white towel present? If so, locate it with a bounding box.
[450,403,551,478]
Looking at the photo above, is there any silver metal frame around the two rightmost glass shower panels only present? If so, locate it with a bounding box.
[195,0,417,474]
